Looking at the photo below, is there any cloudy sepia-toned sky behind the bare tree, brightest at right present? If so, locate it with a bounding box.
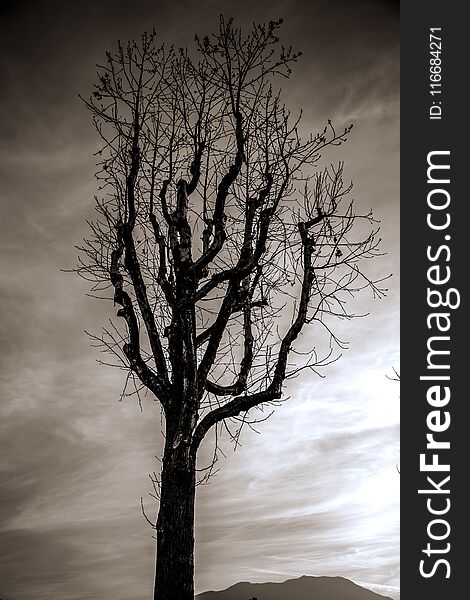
[0,0,400,600]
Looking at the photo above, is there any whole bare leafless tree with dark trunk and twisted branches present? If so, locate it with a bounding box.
[77,18,382,600]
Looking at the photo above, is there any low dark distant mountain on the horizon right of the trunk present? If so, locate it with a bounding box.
[196,576,391,600]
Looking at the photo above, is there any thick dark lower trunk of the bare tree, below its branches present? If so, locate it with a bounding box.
[154,438,196,600]
